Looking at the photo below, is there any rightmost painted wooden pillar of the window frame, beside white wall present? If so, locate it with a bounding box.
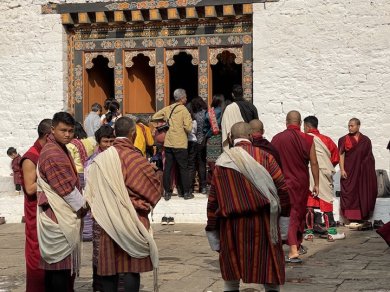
[242,43,253,102]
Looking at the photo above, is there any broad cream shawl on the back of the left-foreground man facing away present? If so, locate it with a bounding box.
[84,146,158,269]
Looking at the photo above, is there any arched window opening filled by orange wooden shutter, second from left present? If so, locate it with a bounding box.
[123,52,156,114]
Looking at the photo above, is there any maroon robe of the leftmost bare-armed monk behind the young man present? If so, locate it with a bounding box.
[20,140,45,292]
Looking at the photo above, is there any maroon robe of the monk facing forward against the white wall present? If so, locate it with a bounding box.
[339,133,378,220]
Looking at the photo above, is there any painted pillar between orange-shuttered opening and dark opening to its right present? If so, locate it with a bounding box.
[155,48,165,111]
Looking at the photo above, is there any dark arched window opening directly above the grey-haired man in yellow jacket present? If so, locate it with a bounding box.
[168,52,198,102]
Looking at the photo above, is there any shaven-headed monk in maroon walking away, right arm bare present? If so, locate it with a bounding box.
[271,111,319,262]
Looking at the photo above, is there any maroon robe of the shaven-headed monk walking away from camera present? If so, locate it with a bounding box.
[271,125,314,246]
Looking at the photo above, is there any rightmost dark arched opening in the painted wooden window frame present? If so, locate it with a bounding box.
[211,49,242,99]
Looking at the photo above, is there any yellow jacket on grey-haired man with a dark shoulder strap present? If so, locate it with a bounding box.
[153,103,192,149]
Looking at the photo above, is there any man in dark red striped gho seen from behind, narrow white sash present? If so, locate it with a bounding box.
[206,122,290,292]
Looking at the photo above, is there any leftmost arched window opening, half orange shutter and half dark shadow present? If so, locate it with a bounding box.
[83,55,115,118]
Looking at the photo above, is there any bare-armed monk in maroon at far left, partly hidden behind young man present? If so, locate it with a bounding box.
[20,119,51,292]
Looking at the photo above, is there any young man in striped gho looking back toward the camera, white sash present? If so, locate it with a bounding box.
[37,112,87,292]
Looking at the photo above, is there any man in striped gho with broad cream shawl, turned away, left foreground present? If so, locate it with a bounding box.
[84,117,163,292]
